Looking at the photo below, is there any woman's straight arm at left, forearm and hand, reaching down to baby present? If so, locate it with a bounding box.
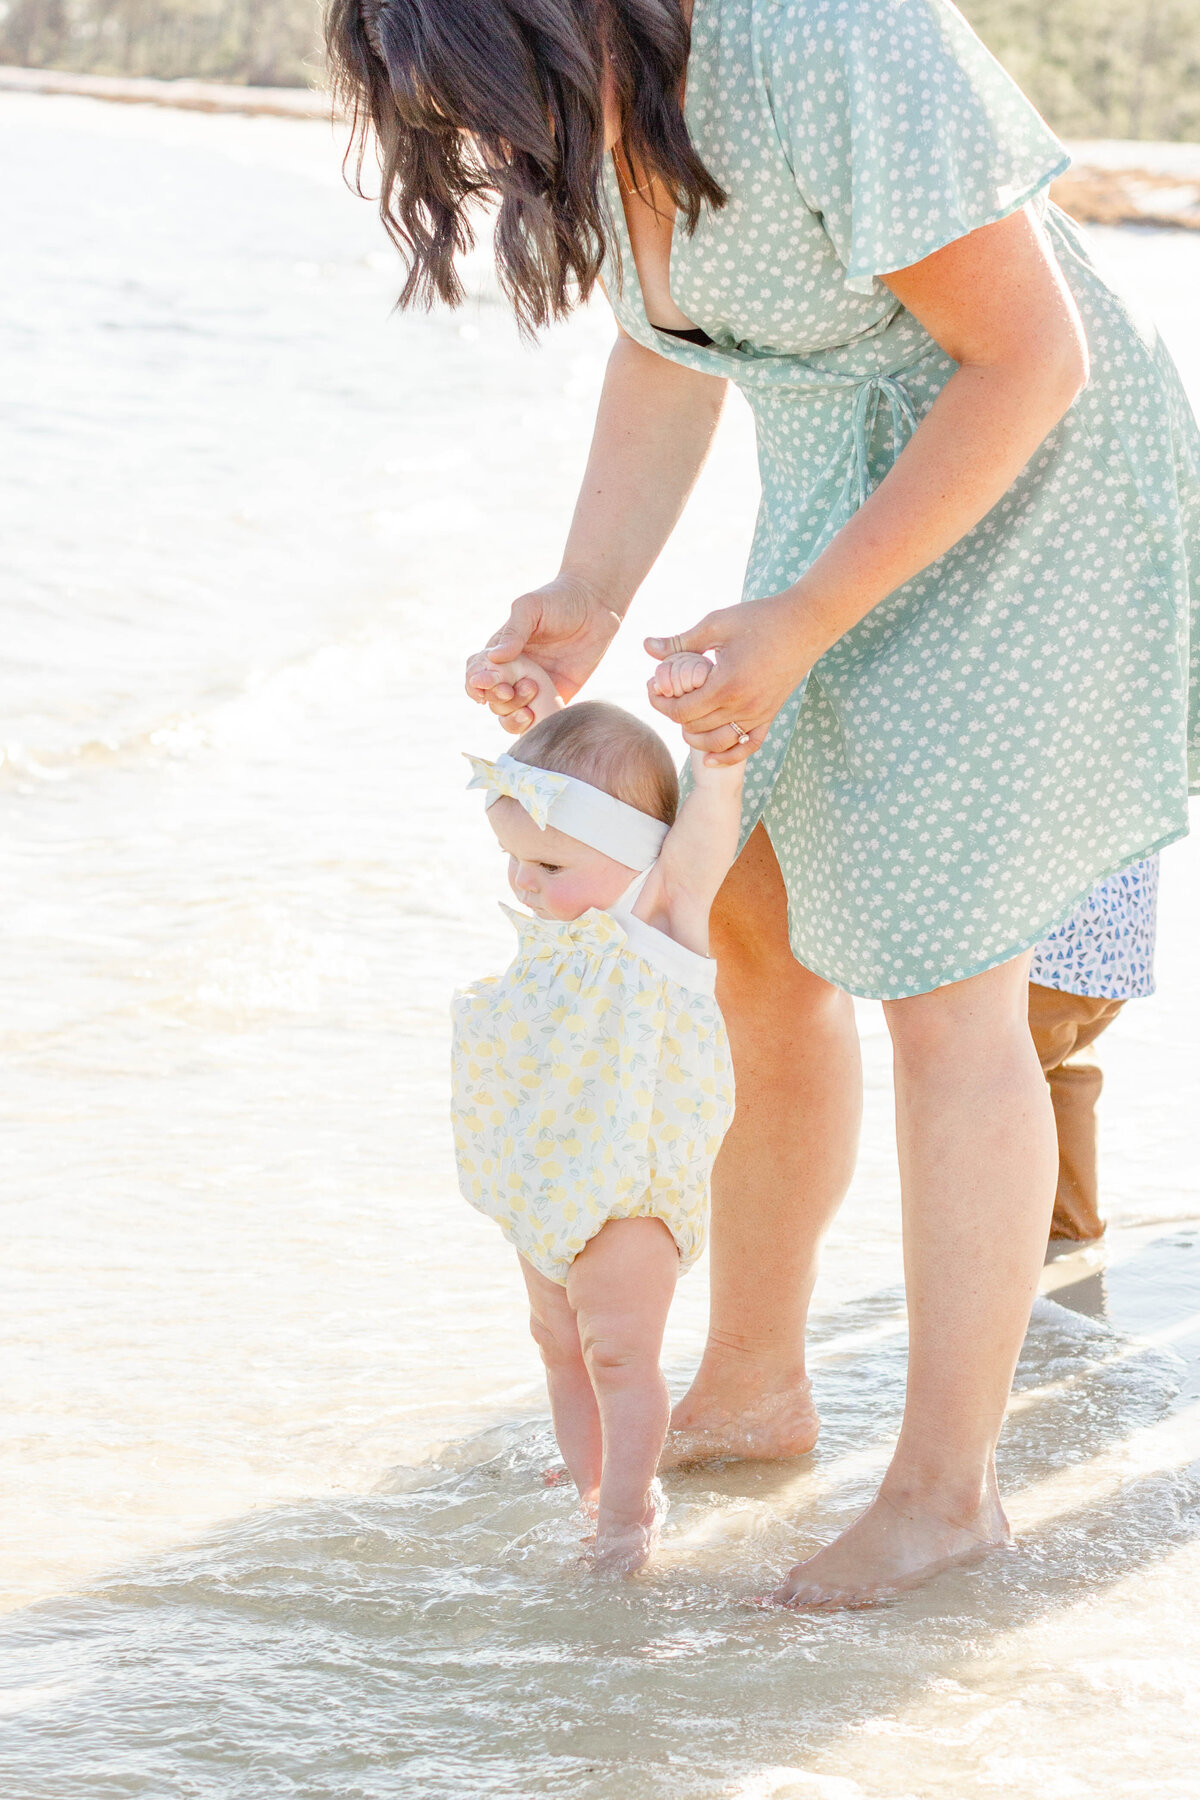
[466,331,727,731]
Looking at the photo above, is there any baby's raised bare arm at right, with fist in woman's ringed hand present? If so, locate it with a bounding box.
[633,652,745,956]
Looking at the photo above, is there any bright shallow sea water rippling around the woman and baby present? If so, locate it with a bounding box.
[0,95,1200,1800]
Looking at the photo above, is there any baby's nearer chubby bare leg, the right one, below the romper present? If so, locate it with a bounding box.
[567,1219,678,1570]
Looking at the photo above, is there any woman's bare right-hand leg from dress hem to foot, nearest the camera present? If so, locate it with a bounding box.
[777,956,1058,1606]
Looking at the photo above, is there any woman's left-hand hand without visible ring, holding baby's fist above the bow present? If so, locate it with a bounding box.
[466,574,621,734]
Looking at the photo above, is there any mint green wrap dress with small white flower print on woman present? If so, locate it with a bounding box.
[606,0,1200,999]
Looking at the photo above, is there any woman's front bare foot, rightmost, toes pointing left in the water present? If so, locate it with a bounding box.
[772,1481,1013,1607]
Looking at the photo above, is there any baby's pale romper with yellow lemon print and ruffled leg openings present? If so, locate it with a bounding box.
[452,875,734,1285]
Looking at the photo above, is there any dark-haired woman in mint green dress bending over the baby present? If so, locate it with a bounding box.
[329,0,1198,1606]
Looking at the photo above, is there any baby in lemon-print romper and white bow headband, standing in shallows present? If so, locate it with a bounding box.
[453,655,743,1573]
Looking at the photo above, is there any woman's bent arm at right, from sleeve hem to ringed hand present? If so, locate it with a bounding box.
[646,211,1088,763]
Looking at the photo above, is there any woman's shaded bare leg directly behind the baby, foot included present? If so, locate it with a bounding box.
[667,824,862,1463]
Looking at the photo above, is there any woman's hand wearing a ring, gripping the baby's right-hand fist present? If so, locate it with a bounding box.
[646,594,824,767]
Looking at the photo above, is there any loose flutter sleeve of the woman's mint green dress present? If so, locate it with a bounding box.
[763,0,1070,293]
